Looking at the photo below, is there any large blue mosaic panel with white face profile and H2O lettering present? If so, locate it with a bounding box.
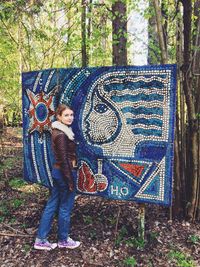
[22,65,176,205]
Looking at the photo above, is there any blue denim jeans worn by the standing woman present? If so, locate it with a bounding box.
[37,168,76,241]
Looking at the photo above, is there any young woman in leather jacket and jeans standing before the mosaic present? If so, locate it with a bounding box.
[34,104,80,250]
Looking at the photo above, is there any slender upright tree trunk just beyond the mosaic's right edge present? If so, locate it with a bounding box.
[173,1,186,217]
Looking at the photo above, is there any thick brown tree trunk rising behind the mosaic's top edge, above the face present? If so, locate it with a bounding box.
[112,0,127,66]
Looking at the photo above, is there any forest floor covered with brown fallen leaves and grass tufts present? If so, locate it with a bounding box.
[0,129,200,267]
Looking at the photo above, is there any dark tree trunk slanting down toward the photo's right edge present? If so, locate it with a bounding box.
[182,0,198,221]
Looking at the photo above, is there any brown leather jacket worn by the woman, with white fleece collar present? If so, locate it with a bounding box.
[52,129,77,189]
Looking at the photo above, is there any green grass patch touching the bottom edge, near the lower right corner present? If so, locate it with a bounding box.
[167,250,195,267]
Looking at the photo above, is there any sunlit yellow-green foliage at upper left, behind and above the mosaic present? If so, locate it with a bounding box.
[0,0,145,114]
